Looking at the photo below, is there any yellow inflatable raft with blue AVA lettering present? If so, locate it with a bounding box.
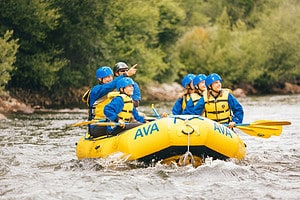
[76,115,246,165]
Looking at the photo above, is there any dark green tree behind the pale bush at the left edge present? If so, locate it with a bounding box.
[0,0,66,90]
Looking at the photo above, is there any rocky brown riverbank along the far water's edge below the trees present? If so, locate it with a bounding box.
[0,83,300,120]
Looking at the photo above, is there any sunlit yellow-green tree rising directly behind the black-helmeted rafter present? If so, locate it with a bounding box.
[98,0,184,85]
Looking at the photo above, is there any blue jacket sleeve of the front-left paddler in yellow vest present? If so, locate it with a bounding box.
[104,96,124,122]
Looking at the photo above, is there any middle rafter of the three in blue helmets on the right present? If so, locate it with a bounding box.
[183,74,206,115]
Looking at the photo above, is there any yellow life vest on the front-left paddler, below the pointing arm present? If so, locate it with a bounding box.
[92,91,120,119]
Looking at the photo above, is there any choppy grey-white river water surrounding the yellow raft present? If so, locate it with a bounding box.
[0,95,300,200]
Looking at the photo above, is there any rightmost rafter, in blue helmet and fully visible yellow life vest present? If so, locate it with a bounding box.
[193,73,244,128]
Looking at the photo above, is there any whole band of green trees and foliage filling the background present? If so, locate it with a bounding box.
[0,0,300,98]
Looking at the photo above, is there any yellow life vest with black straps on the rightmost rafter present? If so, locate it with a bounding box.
[204,89,232,123]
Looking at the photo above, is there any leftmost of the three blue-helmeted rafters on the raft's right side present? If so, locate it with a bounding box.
[172,74,195,115]
